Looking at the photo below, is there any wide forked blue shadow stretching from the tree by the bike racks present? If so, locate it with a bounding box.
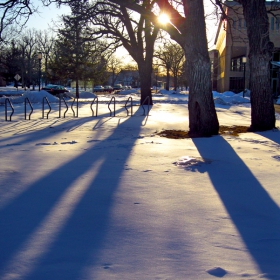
[0,106,149,279]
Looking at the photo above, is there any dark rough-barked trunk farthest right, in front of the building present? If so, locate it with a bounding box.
[239,0,275,131]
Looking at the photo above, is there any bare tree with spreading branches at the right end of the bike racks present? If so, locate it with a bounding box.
[87,0,159,104]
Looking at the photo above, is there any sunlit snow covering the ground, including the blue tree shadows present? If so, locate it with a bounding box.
[0,88,280,280]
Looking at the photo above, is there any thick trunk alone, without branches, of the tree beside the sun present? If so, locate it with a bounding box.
[182,0,219,137]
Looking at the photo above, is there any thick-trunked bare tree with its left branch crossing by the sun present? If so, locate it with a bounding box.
[111,0,219,137]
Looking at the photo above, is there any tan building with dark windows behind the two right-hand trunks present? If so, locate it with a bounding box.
[210,1,280,95]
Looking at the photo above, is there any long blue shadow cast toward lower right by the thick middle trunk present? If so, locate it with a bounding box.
[193,136,280,279]
